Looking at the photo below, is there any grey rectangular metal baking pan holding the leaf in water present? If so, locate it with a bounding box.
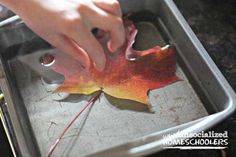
[0,0,236,157]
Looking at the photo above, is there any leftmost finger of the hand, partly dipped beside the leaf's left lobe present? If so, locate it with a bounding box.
[50,35,90,69]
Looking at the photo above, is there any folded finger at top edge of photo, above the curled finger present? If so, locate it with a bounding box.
[93,0,122,17]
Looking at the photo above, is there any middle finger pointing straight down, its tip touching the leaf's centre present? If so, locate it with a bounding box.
[69,27,106,71]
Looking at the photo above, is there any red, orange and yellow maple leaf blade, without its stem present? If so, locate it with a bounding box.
[52,21,178,104]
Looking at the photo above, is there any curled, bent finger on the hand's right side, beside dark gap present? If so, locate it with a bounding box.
[89,7,125,52]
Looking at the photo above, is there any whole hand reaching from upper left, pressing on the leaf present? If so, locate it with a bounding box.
[0,0,125,70]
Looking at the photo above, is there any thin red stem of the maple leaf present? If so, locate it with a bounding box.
[47,91,102,157]
